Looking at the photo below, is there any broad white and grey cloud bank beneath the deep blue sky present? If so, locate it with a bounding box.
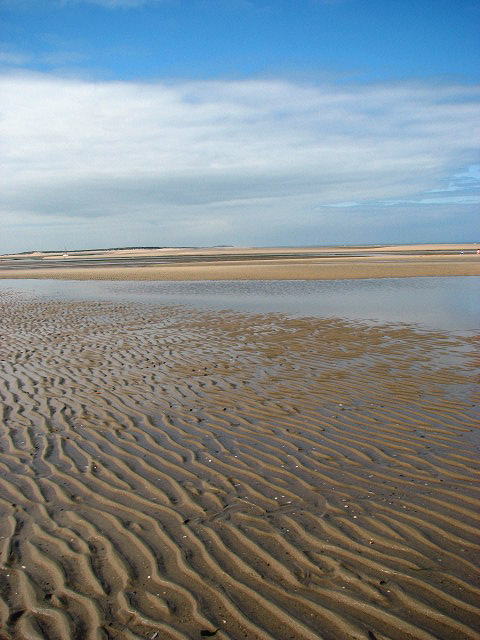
[0,75,480,252]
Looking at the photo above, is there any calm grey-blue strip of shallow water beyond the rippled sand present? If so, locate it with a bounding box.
[0,276,480,332]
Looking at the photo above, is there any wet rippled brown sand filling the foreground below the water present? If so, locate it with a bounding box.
[0,293,480,640]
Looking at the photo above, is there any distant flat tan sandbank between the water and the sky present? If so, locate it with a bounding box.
[0,244,480,281]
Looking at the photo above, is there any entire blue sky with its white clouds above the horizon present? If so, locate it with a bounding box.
[0,0,480,254]
